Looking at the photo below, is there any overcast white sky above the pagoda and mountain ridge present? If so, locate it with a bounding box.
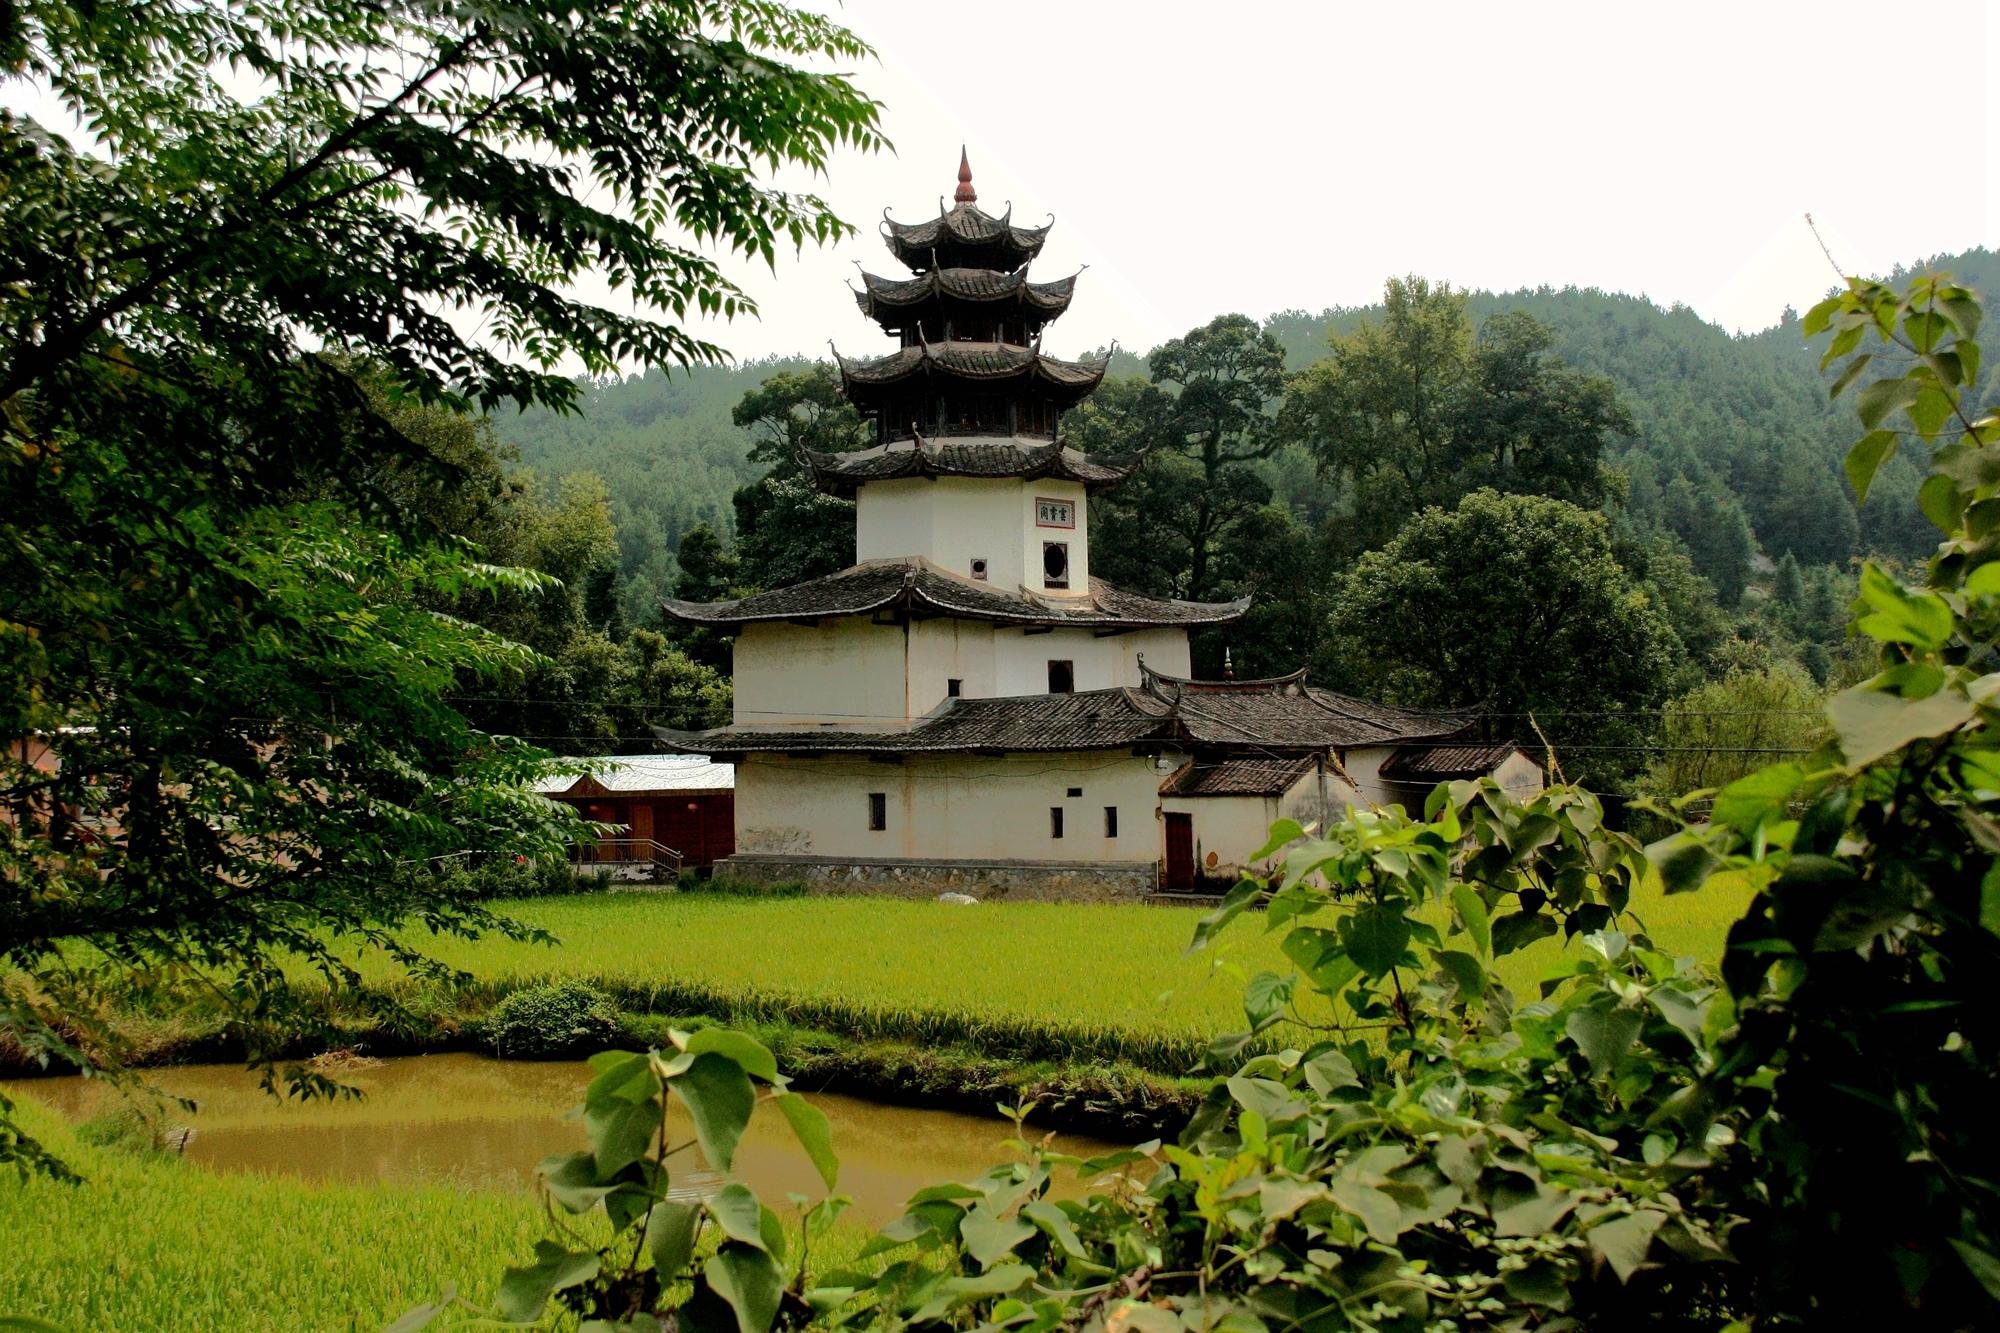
[692,0,2000,358]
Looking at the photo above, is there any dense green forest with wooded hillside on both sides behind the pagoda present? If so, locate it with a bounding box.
[494,250,2000,787]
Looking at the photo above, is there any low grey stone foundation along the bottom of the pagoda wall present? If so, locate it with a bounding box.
[716,853,1160,903]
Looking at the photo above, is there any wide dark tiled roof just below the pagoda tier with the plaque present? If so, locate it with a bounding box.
[660,556,1250,628]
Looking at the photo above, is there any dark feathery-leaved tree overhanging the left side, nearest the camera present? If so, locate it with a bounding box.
[0,0,880,1157]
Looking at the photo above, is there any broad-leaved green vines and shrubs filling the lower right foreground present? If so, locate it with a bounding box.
[460,276,2000,1333]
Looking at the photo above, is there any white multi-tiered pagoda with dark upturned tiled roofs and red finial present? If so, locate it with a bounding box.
[656,158,1542,899]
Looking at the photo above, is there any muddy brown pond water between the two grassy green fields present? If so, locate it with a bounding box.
[8,1055,1144,1223]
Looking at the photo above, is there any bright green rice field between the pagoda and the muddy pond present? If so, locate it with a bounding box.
[376,880,1744,1075]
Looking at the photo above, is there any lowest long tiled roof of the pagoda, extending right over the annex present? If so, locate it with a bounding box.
[654,673,1466,759]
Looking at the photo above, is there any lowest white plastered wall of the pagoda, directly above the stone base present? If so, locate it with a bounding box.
[736,751,1160,863]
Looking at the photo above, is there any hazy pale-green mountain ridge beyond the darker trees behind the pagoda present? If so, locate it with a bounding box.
[496,250,2000,610]
